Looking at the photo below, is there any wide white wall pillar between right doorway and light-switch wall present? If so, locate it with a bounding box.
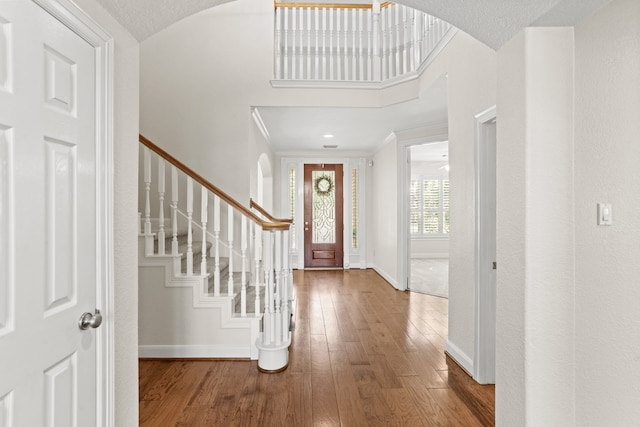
[496,28,575,426]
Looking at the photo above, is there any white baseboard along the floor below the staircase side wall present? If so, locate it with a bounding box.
[138,344,251,359]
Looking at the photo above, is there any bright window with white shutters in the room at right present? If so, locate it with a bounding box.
[409,177,449,237]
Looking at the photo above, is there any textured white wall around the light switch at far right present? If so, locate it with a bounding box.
[575,0,640,426]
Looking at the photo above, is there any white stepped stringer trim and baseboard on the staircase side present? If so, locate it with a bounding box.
[138,234,262,360]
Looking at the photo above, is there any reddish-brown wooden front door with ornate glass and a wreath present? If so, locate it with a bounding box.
[304,164,343,268]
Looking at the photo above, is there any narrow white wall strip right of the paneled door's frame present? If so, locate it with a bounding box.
[76,0,139,427]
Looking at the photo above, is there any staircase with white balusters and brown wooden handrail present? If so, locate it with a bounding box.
[138,136,293,372]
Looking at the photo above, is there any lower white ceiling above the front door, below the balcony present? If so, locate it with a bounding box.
[256,77,447,154]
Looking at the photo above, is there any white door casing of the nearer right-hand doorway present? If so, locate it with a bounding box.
[473,106,497,384]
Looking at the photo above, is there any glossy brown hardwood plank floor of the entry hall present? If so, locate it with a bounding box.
[140,270,494,427]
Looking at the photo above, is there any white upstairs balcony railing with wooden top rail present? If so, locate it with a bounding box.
[274,2,453,83]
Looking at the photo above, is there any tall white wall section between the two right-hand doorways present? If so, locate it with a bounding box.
[447,32,499,371]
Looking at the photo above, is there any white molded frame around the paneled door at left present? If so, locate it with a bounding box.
[32,0,115,427]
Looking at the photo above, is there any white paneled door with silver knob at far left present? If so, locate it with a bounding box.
[0,0,103,427]
